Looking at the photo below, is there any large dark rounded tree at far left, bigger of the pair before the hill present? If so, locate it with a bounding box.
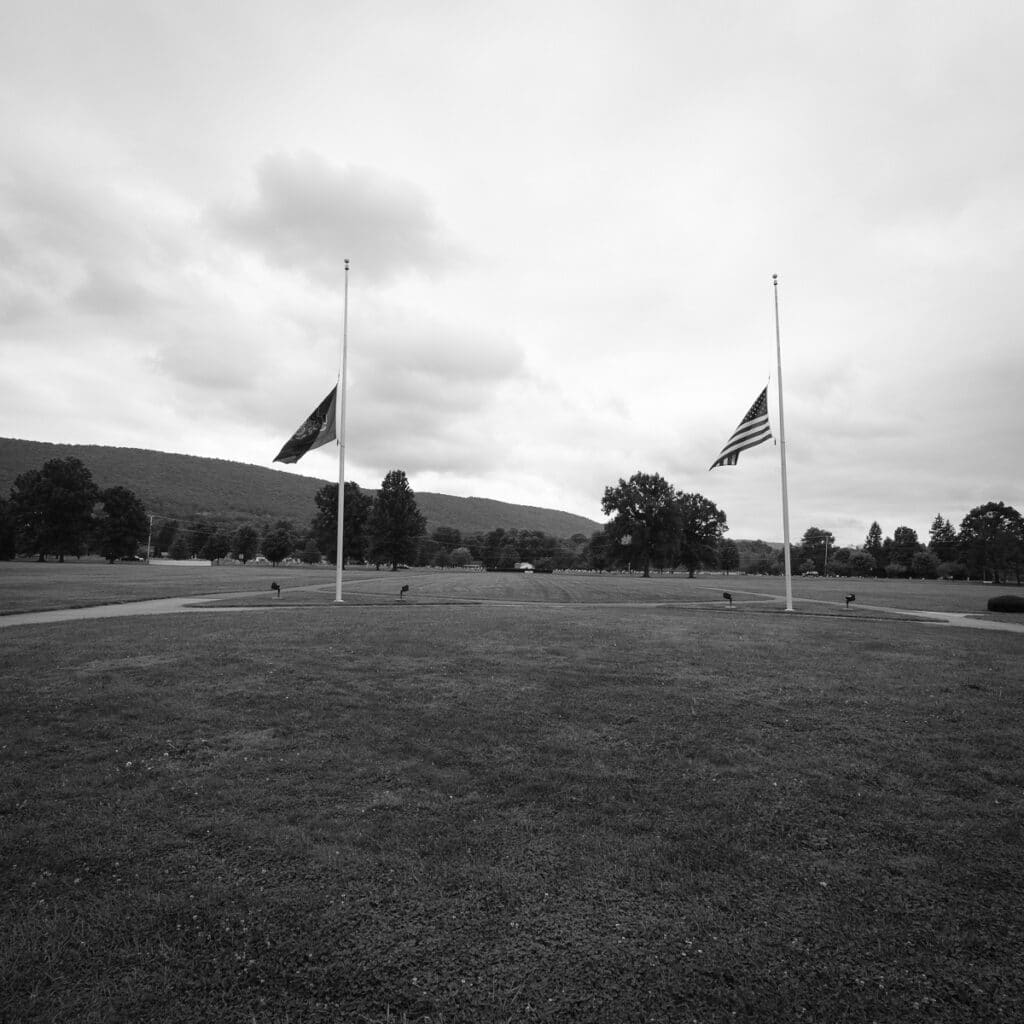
[10,458,99,562]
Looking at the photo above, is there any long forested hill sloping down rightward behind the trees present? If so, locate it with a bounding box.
[0,437,600,538]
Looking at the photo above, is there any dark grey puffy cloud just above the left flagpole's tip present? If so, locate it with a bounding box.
[210,153,459,288]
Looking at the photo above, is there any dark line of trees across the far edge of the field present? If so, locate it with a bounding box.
[0,458,1024,584]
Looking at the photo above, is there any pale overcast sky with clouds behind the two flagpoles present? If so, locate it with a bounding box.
[0,0,1024,544]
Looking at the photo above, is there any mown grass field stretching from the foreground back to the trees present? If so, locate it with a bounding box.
[0,564,1024,1024]
